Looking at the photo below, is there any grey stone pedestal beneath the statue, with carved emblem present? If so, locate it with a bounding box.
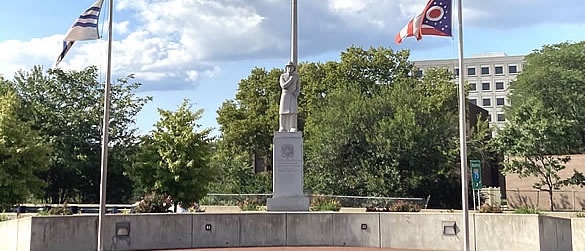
[267,132,309,211]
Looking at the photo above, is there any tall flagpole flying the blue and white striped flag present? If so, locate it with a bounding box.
[97,0,114,251]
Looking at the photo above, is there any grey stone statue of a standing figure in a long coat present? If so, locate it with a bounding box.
[278,62,301,132]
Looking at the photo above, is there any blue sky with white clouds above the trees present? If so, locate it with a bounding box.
[0,0,585,135]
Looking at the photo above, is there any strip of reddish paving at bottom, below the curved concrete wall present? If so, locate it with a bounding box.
[157,247,423,251]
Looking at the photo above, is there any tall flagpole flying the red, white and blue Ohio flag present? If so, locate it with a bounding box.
[457,0,469,251]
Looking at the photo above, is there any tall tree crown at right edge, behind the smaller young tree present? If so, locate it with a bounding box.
[510,41,585,148]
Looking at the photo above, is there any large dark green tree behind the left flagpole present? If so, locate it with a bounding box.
[11,67,151,203]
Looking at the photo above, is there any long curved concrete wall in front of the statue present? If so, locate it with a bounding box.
[0,212,585,251]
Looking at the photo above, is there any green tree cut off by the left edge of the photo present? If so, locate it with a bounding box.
[0,91,50,209]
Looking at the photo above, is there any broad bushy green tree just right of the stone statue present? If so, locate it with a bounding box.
[306,64,464,208]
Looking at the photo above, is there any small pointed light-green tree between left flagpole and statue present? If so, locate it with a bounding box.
[127,99,216,211]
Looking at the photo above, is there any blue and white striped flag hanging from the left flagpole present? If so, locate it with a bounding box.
[55,0,104,66]
